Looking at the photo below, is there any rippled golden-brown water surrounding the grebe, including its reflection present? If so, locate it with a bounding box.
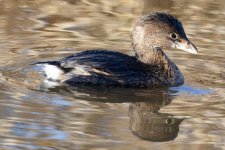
[0,0,225,150]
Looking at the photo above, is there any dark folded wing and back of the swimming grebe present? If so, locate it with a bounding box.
[60,50,158,87]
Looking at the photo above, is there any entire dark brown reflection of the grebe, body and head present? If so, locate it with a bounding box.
[46,86,183,142]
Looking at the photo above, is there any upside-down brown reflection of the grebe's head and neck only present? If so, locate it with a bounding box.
[129,101,183,142]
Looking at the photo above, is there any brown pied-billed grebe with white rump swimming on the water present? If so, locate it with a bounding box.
[36,12,197,87]
